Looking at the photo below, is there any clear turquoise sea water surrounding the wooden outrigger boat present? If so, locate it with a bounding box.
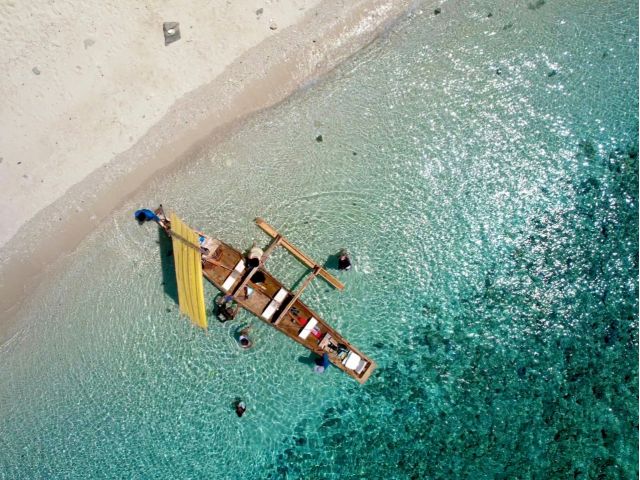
[0,0,638,479]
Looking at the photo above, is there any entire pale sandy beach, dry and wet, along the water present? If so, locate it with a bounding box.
[0,0,410,338]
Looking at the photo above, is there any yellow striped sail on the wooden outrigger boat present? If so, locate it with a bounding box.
[170,213,207,329]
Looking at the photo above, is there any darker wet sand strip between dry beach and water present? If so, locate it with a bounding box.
[0,0,411,345]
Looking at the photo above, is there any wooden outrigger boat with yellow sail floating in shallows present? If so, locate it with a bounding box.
[136,206,376,383]
